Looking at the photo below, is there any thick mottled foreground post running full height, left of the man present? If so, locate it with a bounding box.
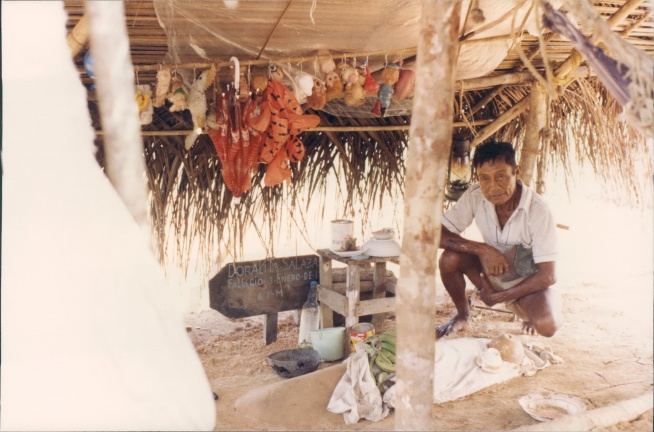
[395,0,461,430]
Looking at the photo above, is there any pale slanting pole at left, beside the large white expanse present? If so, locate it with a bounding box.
[85,1,151,246]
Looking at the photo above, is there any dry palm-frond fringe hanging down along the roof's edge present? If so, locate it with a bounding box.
[89,77,652,272]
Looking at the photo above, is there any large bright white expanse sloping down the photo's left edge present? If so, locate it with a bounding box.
[0,2,215,431]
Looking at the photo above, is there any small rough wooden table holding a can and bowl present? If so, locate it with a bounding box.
[317,249,400,345]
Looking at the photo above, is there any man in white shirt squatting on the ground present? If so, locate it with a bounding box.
[436,142,562,338]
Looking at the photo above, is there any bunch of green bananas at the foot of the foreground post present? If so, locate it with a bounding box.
[359,331,396,394]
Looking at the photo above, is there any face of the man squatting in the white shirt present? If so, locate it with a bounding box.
[477,160,520,205]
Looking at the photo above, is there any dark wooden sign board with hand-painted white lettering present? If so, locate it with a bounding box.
[209,255,320,318]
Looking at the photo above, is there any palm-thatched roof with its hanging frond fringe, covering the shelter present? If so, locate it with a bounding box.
[65,0,654,274]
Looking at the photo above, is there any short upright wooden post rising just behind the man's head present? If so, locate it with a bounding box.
[520,82,547,186]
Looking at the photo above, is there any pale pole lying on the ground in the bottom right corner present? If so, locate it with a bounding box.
[516,392,652,431]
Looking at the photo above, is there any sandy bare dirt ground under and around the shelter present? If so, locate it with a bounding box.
[187,266,653,431]
